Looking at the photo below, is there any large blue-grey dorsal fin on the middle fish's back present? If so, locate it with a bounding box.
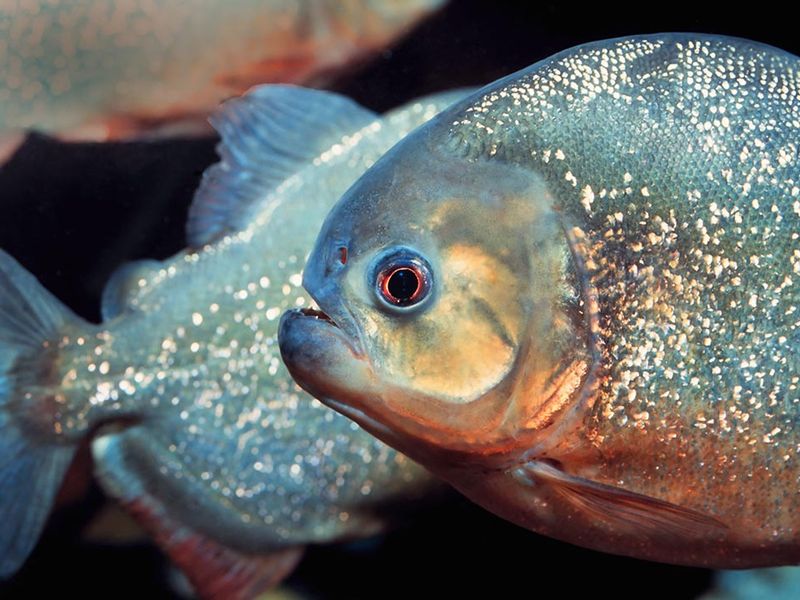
[186,85,377,247]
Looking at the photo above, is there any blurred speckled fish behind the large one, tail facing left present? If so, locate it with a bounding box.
[0,85,463,598]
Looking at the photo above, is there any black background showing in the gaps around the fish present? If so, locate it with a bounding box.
[0,0,800,598]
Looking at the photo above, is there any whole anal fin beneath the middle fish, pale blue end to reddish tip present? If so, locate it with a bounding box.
[92,429,303,600]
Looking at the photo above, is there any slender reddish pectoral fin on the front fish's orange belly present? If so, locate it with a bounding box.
[521,461,727,538]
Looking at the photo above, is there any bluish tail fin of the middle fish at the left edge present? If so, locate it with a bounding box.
[0,250,83,578]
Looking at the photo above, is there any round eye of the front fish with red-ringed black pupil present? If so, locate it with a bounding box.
[372,248,432,309]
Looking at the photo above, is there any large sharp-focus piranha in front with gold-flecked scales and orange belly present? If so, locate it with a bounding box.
[279,34,800,568]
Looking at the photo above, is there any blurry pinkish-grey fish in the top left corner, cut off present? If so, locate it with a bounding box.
[0,0,444,162]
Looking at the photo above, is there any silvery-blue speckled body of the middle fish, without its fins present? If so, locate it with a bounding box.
[7,95,462,569]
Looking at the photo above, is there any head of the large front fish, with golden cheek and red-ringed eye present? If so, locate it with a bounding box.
[280,129,586,460]
